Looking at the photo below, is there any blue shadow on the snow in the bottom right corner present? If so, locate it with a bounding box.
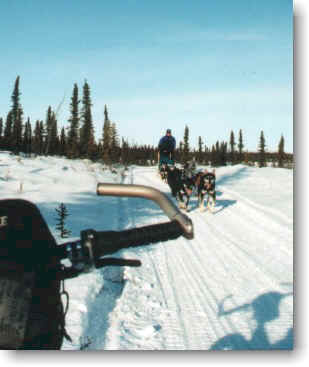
[210,292,293,350]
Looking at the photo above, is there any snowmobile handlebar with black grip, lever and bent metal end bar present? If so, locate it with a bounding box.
[57,184,193,278]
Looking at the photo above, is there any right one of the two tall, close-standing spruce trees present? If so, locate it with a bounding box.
[80,81,96,158]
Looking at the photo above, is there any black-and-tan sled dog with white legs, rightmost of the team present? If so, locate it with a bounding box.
[195,170,216,212]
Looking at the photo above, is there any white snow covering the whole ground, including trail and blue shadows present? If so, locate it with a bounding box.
[0,152,293,350]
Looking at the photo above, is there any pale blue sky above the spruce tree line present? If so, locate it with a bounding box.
[0,0,293,152]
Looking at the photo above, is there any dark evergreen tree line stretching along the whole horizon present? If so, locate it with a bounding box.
[0,76,293,167]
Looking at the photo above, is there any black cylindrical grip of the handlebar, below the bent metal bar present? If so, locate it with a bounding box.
[86,221,184,259]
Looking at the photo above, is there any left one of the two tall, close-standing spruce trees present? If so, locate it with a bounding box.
[68,83,80,158]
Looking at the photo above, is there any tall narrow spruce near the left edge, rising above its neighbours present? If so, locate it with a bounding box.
[11,76,23,154]
